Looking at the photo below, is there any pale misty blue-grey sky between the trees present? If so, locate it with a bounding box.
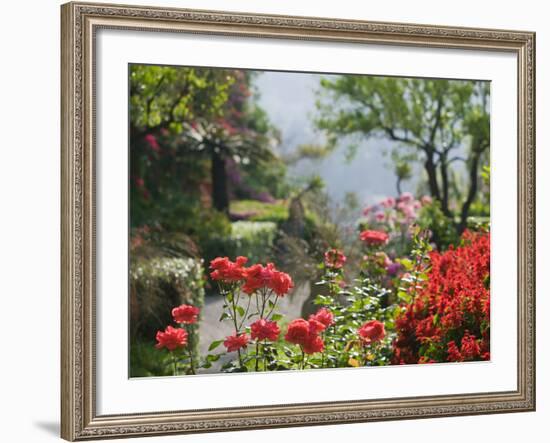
[255,72,417,210]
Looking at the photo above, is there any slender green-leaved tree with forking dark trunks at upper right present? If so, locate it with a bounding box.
[316,75,490,232]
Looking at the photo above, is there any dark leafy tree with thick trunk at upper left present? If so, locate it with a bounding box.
[130,65,280,221]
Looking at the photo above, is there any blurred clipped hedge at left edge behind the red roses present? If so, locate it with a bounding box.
[130,258,204,350]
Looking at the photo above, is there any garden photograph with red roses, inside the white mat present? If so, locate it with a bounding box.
[128,64,491,377]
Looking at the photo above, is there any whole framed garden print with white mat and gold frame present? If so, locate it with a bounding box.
[61,2,535,440]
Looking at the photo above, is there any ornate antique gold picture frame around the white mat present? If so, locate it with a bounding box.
[61,2,535,441]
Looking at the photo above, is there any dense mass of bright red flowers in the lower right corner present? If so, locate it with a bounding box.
[392,231,490,364]
